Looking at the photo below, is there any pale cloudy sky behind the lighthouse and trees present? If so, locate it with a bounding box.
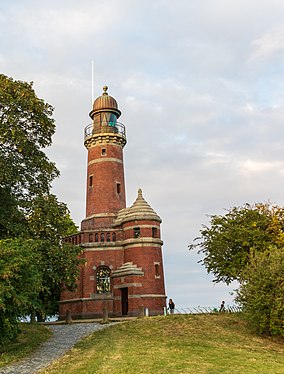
[0,0,284,308]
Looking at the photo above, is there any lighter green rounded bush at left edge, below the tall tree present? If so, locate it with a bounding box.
[0,239,42,347]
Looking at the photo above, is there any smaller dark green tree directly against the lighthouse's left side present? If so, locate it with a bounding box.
[28,194,82,320]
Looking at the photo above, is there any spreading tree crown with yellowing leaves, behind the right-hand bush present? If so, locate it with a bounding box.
[189,203,284,284]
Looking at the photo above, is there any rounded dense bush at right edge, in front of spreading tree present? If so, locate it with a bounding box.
[236,247,284,337]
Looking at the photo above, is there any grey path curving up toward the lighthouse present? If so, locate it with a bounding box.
[0,323,109,374]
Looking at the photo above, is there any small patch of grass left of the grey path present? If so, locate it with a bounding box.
[0,323,51,368]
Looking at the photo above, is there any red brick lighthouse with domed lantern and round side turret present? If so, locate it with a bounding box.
[59,86,166,318]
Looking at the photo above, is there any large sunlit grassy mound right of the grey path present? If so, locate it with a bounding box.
[42,314,284,374]
